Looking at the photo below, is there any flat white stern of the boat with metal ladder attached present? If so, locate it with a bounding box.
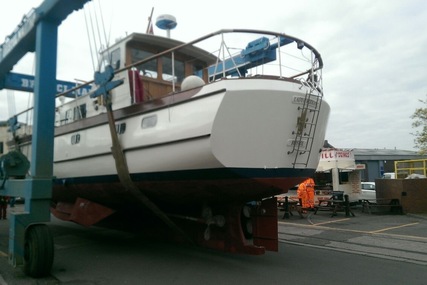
[211,79,330,179]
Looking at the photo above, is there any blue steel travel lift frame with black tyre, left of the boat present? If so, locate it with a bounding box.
[0,0,90,277]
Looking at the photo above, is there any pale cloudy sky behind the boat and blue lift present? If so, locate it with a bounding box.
[0,0,427,150]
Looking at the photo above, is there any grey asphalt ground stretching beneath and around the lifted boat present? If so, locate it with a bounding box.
[0,203,427,285]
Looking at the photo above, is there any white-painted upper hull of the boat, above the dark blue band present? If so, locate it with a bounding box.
[54,77,329,178]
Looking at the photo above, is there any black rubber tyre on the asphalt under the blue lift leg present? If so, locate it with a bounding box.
[24,224,54,278]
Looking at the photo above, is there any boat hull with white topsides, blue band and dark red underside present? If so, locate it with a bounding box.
[53,77,329,208]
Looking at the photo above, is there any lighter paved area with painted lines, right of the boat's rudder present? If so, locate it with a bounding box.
[278,203,427,265]
